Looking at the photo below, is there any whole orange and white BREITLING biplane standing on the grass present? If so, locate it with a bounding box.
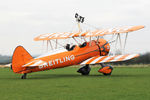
[11,14,144,79]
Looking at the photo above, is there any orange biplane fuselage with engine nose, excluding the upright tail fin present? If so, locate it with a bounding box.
[13,39,110,74]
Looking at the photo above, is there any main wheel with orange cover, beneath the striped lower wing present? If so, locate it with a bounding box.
[98,65,113,76]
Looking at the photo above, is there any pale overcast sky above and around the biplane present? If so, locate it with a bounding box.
[0,0,150,55]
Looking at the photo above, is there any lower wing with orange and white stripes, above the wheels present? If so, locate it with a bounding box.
[80,54,139,65]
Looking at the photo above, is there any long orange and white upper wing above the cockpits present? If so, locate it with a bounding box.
[34,25,144,41]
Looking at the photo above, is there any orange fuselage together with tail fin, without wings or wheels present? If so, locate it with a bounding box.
[12,39,110,74]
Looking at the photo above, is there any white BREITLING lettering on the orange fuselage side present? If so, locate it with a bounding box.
[39,55,75,69]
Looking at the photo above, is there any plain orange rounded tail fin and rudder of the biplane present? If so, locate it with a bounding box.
[12,46,33,73]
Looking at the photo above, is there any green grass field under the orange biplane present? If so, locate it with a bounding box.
[0,67,150,100]
